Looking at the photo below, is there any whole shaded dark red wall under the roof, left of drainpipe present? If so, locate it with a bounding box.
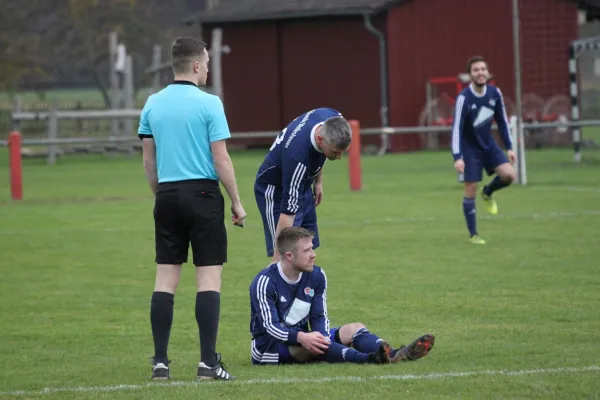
[204,15,385,148]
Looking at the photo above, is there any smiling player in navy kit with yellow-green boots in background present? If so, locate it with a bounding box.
[452,56,516,244]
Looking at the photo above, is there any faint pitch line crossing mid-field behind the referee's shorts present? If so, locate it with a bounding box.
[0,210,600,236]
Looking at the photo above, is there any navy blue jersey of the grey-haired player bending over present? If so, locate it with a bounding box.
[256,108,342,215]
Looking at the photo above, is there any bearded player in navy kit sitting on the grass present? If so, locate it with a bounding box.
[250,227,435,365]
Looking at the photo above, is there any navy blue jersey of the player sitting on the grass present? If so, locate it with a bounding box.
[250,263,330,346]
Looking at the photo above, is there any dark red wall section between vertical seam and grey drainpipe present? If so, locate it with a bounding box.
[280,18,380,126]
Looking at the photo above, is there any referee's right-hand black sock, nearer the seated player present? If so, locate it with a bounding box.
[196,291,221,367]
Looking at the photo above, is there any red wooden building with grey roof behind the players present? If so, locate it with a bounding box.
[185,0,578,150]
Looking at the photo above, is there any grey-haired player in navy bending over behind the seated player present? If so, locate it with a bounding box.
[254,108,352,262]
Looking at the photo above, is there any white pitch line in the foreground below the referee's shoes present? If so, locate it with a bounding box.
[0,365,600,396]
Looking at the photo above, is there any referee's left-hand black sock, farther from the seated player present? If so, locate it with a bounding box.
[150,292,175,365]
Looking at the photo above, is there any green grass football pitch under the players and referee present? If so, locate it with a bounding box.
[0,150,600,399]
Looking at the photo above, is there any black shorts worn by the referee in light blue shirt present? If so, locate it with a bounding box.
[154,179,227,267]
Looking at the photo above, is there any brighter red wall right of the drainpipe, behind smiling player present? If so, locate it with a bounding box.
[387,0,578,150]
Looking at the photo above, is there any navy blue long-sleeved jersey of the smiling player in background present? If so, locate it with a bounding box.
[452,85,512,160]
